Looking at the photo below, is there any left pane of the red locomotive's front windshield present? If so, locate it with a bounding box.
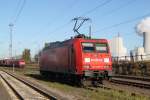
[82,43,95,52]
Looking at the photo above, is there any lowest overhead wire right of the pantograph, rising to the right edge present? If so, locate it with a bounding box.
[93,12,150,33]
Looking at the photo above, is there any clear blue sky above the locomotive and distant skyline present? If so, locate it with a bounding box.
[0,0,150,58]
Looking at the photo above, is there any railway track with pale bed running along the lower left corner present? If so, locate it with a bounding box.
[0,71,57,100]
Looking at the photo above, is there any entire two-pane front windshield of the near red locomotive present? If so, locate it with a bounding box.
[82,43,108,53]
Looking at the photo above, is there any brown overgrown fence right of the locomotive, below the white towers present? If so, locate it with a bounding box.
[112,54,150,76]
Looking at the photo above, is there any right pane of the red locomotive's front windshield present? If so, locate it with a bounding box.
[95,43,108,53]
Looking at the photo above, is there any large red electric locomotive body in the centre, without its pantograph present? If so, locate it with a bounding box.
[40,35,112,85]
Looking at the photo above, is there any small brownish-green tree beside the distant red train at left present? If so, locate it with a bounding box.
[22,49,31,63]
